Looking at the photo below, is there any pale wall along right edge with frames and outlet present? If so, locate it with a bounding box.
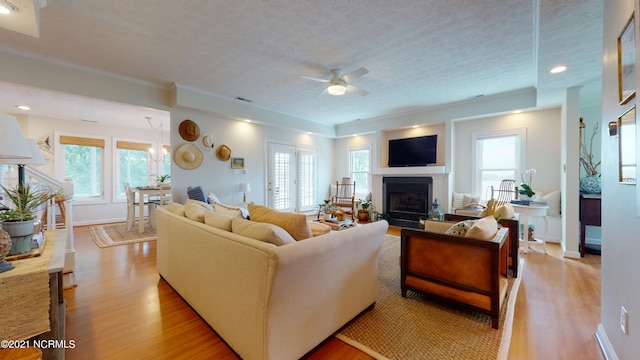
[598,0,640,359]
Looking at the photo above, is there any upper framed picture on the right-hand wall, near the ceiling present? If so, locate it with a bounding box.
[618,14,636,104]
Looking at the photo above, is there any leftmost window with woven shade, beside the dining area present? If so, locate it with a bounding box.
[60,135,105,198]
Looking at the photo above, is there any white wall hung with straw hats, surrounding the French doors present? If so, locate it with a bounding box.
[171,108,335,205]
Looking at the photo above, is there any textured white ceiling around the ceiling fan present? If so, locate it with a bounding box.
[0,0,603,129]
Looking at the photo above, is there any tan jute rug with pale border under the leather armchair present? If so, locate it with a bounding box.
[336,235,524,360]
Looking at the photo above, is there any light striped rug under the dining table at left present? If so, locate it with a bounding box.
[89,222,157,248]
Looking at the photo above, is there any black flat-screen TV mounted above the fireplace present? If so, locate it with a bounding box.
[388,135,438,167]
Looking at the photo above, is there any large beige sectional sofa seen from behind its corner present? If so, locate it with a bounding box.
[156,202,388,360]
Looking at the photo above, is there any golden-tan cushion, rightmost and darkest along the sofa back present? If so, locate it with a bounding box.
[249,204,312,240]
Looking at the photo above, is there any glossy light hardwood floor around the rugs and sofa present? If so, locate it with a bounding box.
[64,227,604,360]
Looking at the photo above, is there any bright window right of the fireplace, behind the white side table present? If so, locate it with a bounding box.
[473,129,524,200]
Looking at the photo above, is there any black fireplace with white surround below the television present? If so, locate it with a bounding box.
[382,176,433,228]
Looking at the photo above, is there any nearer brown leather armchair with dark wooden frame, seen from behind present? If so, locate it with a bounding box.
[401,219,509,329]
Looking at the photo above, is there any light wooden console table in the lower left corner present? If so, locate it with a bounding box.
[0,230,66,359]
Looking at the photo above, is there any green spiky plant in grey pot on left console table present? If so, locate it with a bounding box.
[0,185,59,255]
